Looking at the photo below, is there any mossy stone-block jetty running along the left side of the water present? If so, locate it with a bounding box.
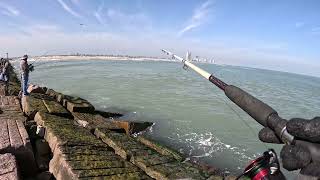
[0,61,233,180]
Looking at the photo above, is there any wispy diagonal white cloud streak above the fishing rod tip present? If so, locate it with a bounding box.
[178,0,212,36]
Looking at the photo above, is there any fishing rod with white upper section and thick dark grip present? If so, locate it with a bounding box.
[161,49,320,179]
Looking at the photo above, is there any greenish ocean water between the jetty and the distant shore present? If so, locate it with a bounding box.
[13,60,320,177]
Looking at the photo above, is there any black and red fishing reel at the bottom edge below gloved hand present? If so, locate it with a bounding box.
[236,149,282,180]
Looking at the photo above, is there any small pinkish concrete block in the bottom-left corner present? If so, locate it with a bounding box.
[0,153,20,180]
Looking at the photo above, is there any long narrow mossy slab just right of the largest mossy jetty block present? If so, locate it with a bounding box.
[94,128,209,179]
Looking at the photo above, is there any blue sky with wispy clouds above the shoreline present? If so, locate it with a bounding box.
[0,0,320,77]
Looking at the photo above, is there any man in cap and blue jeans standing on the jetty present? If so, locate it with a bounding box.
[20,55,30,96]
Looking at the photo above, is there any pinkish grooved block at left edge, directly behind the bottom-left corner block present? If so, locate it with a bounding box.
[0,118,36,176]
